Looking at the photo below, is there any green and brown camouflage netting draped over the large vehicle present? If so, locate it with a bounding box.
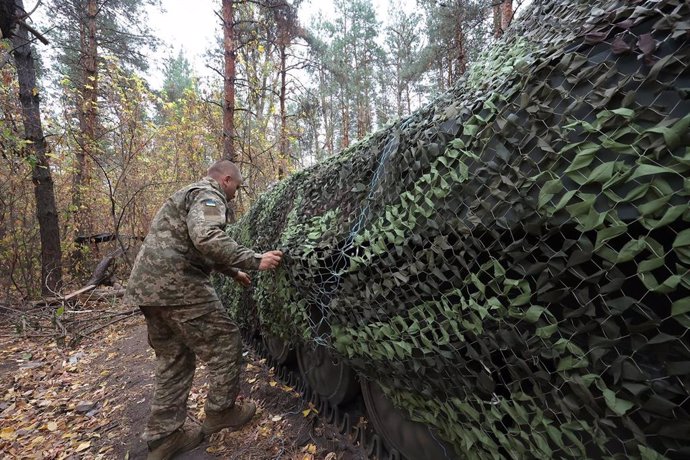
[215,0,690,459]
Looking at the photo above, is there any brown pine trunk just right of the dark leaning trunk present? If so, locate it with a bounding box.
[72,0,98,243]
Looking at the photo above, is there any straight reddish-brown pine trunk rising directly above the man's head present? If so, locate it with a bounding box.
[223,0,236,161]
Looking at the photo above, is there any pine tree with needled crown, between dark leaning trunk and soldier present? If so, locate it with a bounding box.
[48,0,157,252]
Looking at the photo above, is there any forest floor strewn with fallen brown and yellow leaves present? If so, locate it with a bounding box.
[0,290,365,460]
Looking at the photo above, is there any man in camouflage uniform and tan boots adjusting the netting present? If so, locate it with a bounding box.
[127,160,282,460]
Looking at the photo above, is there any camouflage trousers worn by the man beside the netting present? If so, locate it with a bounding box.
[141,302,242,441]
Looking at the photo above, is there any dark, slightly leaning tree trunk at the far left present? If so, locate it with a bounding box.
[12,0,62,295]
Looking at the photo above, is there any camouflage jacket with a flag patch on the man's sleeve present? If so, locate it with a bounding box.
[125,177,261,306]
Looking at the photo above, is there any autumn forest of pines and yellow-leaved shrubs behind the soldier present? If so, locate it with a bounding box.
[0,0,522,305]
